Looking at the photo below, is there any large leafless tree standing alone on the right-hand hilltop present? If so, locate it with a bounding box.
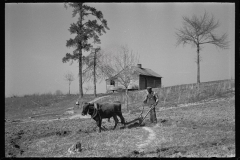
[176,12,229,83]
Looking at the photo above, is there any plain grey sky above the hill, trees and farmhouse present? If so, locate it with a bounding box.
[5,3,235,96]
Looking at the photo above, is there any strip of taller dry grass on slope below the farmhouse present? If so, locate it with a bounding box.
[93,80,235,109]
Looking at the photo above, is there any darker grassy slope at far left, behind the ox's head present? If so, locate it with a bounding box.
[5,94,94,121]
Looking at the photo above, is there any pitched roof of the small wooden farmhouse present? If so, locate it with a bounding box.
[106,66,162,80]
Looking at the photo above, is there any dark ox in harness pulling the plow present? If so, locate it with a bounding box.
[82,101,125,132]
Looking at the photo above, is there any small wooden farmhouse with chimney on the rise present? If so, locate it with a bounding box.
[106,64,162,93]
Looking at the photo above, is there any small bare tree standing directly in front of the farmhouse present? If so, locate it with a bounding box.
[103,45,139,110]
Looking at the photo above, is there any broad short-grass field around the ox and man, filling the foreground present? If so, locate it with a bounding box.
[5,79,235,157]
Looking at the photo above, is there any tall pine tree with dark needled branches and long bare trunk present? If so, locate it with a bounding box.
[62,3,109,98]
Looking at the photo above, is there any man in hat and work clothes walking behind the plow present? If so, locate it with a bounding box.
[143,87,159,123]
